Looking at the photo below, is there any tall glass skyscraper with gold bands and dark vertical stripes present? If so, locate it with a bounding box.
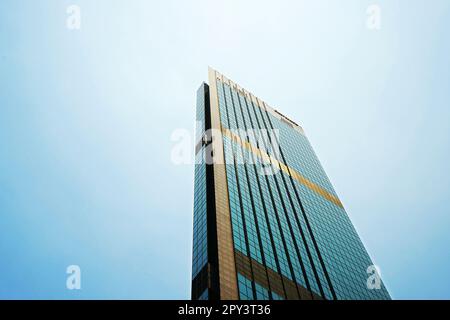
[192,68,390,300]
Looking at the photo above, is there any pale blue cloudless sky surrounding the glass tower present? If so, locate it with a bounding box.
[0,0,450,299]
